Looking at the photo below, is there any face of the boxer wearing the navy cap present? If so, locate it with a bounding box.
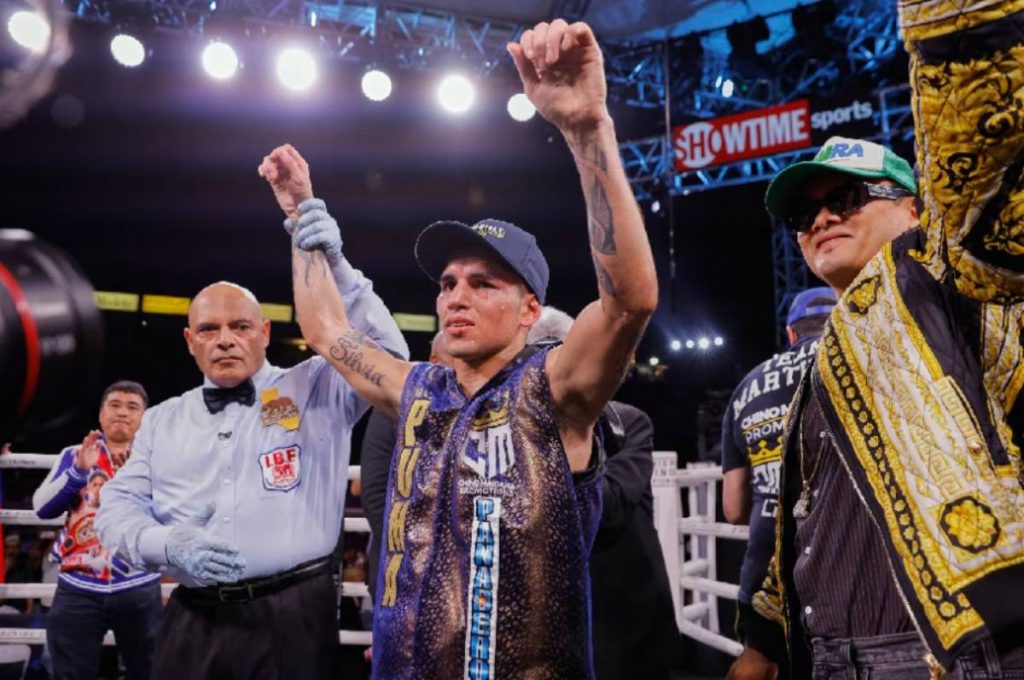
[437,253,541,362]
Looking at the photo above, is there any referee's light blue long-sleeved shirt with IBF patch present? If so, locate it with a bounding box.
[96,258,409,586]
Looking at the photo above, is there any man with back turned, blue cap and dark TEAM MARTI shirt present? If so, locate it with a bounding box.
[722,287,836,655]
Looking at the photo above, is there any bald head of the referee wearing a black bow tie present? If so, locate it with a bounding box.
[184,284,270,387]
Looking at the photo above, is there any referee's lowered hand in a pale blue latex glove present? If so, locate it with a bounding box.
[164,506,246,585]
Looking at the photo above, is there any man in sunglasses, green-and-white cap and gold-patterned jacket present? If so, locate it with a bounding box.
[729,0,1024,667]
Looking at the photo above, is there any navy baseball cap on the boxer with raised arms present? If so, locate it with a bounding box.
[416,219,549,304]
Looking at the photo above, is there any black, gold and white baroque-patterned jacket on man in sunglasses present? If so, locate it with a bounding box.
[745,0,1024,677]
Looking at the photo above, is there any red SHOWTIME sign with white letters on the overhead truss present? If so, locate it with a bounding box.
[673,99,811,172]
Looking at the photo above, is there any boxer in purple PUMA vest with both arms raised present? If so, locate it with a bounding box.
[272,19,657,680]
